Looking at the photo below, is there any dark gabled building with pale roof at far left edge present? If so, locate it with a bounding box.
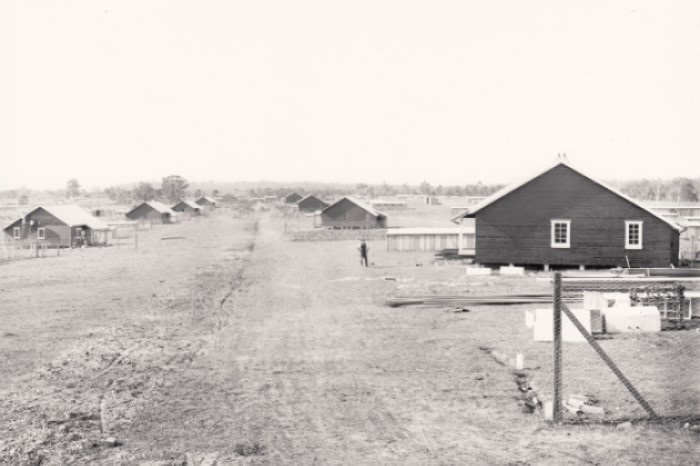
[4,205,110,247]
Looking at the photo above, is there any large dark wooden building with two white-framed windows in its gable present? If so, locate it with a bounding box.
[453,161,681,267]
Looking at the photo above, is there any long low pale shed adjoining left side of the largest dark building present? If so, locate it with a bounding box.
[386,226,476,256]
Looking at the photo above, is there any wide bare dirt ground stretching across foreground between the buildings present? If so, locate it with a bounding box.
[0,211,700,465]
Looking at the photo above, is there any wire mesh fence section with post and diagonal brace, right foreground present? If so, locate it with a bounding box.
[552,279,700,423]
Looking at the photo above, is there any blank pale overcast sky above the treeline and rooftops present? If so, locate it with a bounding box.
[0,0,700,189]
